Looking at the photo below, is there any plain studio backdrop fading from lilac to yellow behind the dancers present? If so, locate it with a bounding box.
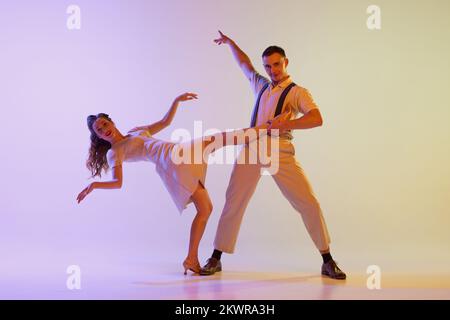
[0,0,450,298]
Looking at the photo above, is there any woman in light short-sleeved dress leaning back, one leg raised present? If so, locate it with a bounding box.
[77,93,284,274]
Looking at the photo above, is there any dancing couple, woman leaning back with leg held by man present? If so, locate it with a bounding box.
[77,31,346,279]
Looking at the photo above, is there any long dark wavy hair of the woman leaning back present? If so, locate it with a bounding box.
[86,113,114,178]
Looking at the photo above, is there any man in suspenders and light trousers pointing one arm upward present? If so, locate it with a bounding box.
[200,31,346,279]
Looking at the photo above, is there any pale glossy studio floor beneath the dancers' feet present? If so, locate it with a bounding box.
[0,262,450,300]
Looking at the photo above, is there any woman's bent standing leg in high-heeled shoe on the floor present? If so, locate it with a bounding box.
[183,183,212,274]
